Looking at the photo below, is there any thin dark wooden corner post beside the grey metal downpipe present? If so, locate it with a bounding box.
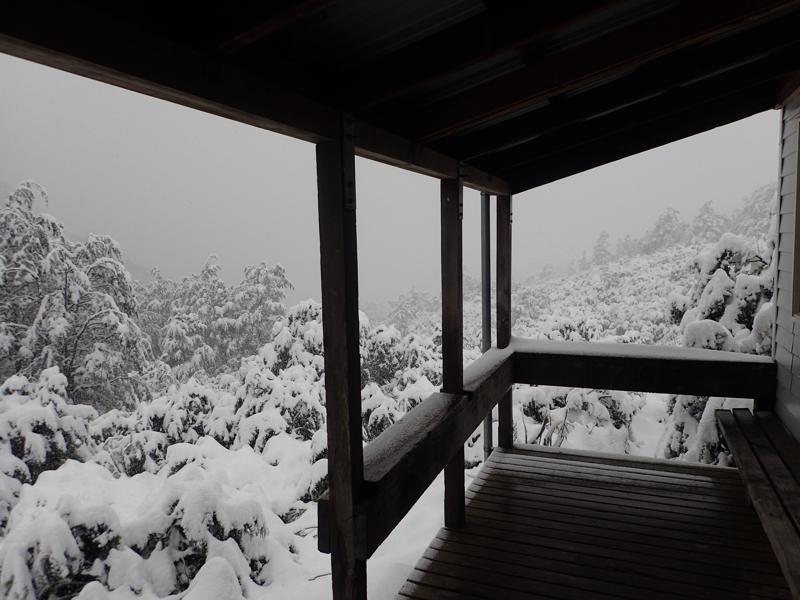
[497,195,514,448]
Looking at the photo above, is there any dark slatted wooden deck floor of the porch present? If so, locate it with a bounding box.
[398,447,791,600]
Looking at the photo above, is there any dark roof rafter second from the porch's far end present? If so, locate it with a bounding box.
[436,16,800,162]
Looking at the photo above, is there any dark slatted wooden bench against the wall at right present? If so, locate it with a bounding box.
[716,408,800,598]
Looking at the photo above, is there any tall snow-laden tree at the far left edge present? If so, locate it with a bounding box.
[0,182,151,409]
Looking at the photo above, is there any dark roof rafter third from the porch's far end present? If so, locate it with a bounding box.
[408,0,800,143]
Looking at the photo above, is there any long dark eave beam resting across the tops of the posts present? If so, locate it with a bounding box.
[0,0,509,193]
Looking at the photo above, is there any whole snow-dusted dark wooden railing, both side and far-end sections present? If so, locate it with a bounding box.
[318,338,776,559]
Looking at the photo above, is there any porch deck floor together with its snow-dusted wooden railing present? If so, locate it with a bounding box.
[319,338,780,599]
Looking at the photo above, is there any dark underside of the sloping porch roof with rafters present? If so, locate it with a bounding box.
[0,0,800,193]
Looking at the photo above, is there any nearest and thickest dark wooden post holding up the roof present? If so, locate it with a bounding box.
[317,118,367,600]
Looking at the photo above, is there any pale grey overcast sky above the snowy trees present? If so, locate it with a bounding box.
[0,54,779,302]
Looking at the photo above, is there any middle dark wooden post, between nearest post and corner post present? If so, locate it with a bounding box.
[441,178,465,527]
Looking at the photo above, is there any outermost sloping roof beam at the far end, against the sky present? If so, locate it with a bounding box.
[503,83,776,194]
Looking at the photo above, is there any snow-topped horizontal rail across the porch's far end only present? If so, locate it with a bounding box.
[512,338,776,410]
